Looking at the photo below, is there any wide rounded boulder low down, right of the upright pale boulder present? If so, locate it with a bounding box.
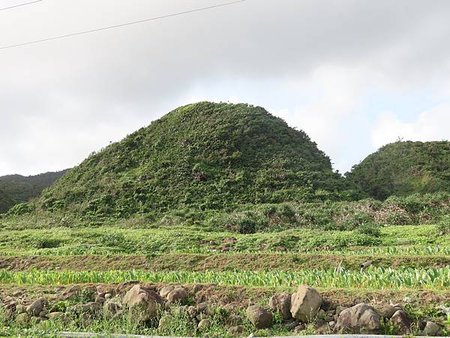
[336,303,381,333]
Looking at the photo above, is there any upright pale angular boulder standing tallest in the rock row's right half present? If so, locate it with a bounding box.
[291,285,322,323]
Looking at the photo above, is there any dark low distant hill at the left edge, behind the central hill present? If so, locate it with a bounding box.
[0,170,67,213]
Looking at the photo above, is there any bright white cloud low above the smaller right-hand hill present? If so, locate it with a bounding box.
[371,103,450,148]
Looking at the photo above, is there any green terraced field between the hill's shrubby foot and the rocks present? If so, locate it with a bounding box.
[0,225,450,336]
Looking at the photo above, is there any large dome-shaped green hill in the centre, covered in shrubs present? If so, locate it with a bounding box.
[38,102,341,217]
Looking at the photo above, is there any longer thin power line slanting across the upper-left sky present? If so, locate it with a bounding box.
[0,0,247,50]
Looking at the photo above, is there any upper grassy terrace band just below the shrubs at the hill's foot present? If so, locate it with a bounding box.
[0,225,444,256]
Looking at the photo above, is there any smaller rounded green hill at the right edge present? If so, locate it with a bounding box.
[347,141,450,199]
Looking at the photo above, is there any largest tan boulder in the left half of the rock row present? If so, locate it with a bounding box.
[123,284,162,324]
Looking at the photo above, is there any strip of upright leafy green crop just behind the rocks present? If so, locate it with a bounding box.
[0,267,450,290]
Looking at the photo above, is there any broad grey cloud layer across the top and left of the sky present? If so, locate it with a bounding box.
[0,0,450,174]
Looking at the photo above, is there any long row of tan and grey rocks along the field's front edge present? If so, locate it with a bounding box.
[2,283,445,336]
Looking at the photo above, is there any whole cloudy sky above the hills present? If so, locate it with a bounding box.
[0,0,450,175]
